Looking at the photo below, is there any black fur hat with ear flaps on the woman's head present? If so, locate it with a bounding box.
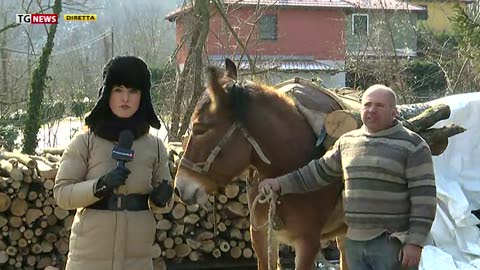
[85,56,160,129]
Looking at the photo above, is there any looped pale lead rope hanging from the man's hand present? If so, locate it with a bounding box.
[247,173,278,270]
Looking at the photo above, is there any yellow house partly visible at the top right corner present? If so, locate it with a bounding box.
[411,0,475,33]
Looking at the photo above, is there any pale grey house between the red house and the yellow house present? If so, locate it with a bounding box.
[346,0,424,59]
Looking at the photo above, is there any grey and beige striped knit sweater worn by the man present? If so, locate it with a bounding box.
[277,122,436,246]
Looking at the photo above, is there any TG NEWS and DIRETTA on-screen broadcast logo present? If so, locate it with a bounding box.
[15,14,97,24]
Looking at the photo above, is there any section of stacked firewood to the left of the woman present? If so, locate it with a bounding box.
[0,152,70,269]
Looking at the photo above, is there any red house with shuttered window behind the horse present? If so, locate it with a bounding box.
[166,0,351,87]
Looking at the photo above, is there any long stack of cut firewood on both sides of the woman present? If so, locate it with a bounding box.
[0,147,254,269]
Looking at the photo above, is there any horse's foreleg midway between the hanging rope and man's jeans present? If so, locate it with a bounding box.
[295,238,320,270]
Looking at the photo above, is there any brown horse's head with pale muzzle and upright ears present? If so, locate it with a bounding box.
[175,59,252,204]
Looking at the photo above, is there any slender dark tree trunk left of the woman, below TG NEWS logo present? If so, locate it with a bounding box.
[23,0,62,154]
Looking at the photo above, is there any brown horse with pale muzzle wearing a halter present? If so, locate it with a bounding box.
[175,59,346,270]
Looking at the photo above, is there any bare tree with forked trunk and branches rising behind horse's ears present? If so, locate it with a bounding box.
[169,0,284,140]
